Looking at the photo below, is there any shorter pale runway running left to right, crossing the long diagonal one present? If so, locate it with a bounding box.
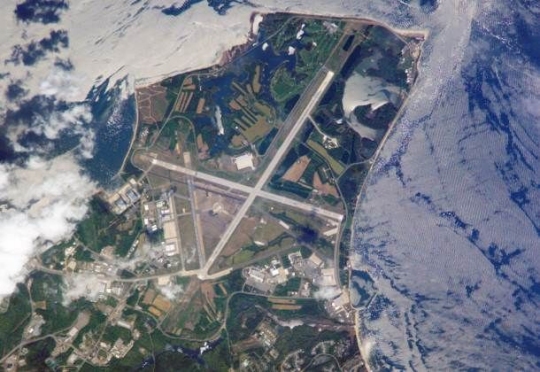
[152,159,344,222]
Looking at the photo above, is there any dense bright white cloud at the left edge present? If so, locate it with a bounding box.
[0,155,95,296]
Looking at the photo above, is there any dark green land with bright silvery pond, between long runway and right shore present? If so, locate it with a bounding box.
[267,23,415,221]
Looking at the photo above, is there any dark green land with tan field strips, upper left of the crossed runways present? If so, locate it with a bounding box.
[129,14,345,184]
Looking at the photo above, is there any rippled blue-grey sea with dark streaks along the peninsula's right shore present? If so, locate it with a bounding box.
[351,1,540,371]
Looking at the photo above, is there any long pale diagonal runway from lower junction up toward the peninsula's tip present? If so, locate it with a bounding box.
[199,68,334,280]
